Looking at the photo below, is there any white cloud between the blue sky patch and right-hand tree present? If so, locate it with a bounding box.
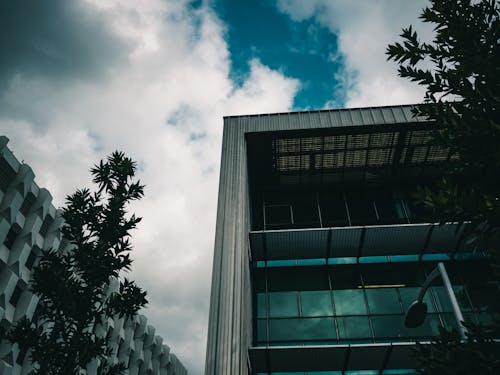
[277,0,430,107]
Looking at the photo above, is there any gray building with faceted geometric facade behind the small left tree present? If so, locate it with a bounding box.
[0,136,187,375]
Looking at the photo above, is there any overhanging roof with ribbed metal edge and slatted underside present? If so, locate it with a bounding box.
[243,106,455,188]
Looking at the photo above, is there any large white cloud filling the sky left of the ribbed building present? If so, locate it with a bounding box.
[0,0,298,374]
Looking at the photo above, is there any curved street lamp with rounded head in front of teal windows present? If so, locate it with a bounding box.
[405,262,467,340]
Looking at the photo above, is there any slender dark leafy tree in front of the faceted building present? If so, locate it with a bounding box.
[8,152,147,375]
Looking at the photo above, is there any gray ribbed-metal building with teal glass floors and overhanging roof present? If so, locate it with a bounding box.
[205,106,500,375]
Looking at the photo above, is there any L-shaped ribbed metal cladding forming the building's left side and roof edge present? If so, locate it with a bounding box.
[205,106,423,375]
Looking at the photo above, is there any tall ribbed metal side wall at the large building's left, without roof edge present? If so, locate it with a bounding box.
[205,117,258,375]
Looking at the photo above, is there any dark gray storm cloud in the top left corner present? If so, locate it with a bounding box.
[0,0,127,91]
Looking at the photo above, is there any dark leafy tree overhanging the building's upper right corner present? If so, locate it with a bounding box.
[386,0,500,241]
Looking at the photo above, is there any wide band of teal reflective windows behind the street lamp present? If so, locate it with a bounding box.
[254,262,500,346]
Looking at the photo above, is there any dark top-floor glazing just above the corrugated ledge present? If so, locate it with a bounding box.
[253,188,432,230]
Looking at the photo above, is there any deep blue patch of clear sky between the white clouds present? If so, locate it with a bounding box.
[214,0,346,110]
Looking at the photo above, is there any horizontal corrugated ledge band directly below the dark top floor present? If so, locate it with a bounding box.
[249,223,477,261]
